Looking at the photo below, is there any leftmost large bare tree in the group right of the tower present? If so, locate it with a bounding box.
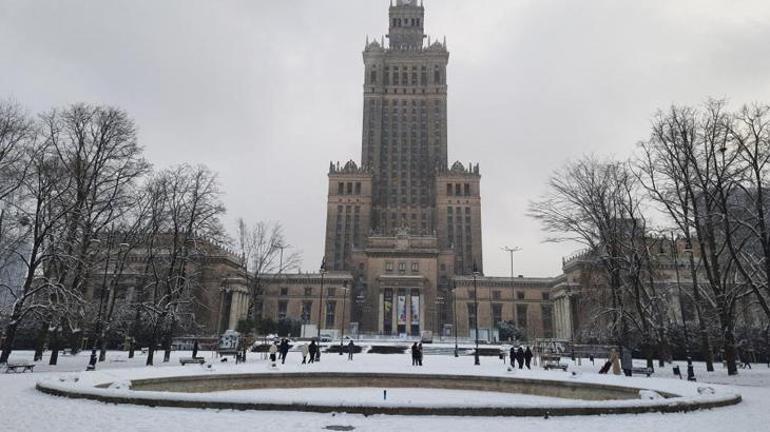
[529,157,666,352]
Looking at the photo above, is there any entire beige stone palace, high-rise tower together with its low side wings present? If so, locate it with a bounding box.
[217,0,572,338]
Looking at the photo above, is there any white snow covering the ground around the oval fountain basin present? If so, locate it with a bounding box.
[0,352,770,432]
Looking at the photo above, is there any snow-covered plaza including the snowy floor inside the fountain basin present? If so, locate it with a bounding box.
[0,351,770,431]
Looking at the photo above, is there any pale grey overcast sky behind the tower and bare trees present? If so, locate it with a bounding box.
[0,0,770,276]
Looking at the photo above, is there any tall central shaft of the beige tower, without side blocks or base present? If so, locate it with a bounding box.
[361,0,449,235]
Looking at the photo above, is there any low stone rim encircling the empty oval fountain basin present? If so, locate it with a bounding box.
[37,373,741,416]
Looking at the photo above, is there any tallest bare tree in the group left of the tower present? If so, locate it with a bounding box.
[33,104,149,362]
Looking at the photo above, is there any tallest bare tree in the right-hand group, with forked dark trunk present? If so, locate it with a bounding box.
[641,100,750,374]
